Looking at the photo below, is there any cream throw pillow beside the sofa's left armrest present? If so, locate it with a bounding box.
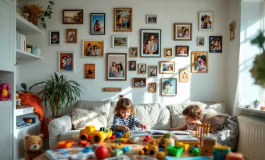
[72,108,107,130]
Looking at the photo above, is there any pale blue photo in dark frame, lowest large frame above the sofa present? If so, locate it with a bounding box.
[161,78,178,96]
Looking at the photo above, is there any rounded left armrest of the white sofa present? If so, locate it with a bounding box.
[48,115,72,149]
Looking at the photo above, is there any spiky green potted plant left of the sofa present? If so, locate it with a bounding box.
[32,72,81,123]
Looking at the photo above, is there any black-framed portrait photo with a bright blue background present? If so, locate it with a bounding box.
[90,13,106,35]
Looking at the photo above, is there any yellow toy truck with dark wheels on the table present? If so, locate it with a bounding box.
[79,126,112,144]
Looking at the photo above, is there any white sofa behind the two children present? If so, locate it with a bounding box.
[48,100,224,148]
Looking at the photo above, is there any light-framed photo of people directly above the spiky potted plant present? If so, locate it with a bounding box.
[58,51,75,72]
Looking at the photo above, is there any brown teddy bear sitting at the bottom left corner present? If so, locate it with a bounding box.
[24,134,44,160]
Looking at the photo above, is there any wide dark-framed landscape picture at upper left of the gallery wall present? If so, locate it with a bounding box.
[63,9,84,24]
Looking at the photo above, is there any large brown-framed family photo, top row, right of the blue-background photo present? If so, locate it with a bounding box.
[113,8,133,32]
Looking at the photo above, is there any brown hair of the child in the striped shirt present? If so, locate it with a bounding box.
[114,95,134,115]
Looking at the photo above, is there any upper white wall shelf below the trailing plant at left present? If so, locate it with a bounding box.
[16,13,43,34]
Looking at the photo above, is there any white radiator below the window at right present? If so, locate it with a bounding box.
[237,116,265,160]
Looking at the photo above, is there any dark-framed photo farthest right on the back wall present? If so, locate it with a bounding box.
[209,36,223,53]
